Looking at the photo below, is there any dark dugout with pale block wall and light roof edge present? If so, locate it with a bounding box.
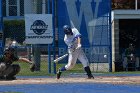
[112,10,140,71]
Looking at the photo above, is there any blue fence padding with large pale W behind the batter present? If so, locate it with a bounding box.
[58,0,111,62]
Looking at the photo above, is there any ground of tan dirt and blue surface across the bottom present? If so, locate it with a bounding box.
[0,72,140,93]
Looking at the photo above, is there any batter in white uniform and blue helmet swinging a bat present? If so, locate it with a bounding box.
[57,25,94,79]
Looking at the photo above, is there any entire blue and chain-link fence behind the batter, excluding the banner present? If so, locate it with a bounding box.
[2,0,112,75]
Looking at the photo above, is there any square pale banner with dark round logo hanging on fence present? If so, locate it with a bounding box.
[25,14,53,44]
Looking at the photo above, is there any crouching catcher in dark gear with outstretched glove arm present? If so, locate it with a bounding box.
[0,47,35,80]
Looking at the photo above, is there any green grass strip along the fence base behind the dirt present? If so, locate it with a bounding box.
[14,61,140,76]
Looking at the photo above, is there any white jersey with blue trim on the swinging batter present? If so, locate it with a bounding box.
[64,28,81,50]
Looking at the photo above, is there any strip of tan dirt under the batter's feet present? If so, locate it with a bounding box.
[0,76,140,85]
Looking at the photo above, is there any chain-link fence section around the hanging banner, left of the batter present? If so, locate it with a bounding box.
[2,0,56,75]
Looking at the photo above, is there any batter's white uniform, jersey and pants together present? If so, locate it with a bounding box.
[64,28,89,70]
